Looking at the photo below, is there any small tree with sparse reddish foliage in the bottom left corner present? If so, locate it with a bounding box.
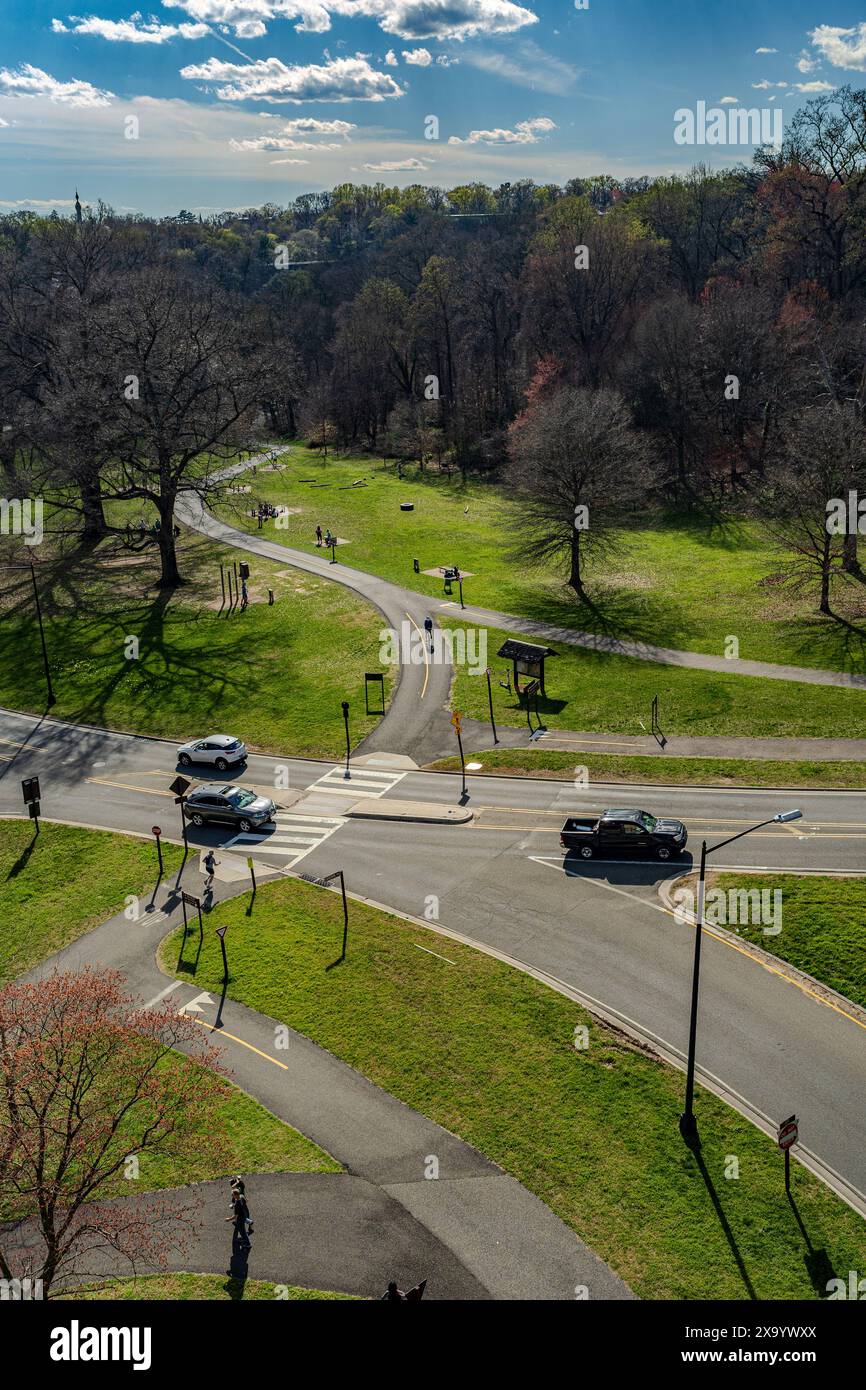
[0,969,225,1297]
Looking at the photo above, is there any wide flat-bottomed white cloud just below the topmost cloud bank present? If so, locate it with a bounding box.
[181,54,403,103]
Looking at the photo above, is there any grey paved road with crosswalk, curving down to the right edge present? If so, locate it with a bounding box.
[0,714,866,1217]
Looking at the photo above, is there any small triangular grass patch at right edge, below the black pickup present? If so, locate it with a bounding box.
[708,873,866,1009]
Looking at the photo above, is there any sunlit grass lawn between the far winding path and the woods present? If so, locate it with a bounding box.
[218,443,866,671]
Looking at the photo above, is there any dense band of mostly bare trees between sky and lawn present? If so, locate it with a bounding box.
[0,88,866,613]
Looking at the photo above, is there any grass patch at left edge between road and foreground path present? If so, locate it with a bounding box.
[0,820,182,984]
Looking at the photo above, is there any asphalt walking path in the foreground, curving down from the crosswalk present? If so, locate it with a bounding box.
[17,855,632,1300]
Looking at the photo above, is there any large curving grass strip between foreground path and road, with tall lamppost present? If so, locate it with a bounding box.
[161,880,866,1298]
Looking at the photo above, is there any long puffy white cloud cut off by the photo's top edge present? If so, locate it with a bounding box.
[163,0,538,40]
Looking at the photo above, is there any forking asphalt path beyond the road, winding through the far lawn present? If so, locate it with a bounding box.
[177,453,866,765]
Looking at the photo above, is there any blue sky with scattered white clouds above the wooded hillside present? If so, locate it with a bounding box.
[0,0,866,214]
